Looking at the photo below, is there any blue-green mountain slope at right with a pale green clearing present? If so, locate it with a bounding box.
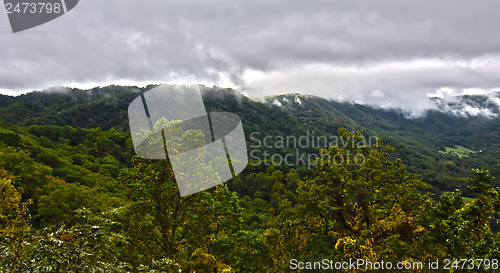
[265,94,500,193]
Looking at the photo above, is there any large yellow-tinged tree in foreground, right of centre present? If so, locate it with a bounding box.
[266,129,433,269]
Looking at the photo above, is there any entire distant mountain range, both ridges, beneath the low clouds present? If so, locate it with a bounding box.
[0,85,500,194]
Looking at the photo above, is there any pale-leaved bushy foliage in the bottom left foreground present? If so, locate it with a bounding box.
[22,208,131,273]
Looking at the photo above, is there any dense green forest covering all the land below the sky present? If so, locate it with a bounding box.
[0,86,500,272]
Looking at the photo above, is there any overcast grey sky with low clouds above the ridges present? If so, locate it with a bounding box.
[0,0,500,112]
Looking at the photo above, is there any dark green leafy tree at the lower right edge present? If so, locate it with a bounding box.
[430,169,500,260]
